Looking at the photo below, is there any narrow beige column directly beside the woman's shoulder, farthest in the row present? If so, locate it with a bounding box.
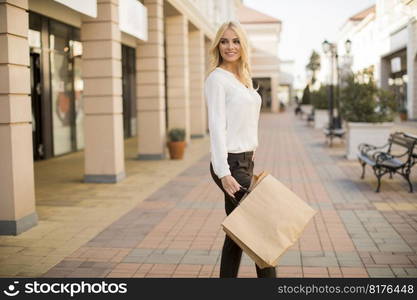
[189,30,207,138]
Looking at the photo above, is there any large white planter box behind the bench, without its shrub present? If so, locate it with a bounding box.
[346,122,394,159]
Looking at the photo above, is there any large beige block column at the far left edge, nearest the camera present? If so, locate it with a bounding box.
[0,0,38,235]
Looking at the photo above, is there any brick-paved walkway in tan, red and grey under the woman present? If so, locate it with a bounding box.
[0,113,417,277]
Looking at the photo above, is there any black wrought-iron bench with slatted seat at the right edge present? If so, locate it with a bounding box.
[358,132,417,193]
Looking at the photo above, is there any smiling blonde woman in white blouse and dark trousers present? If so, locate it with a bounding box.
[204,22,276,278]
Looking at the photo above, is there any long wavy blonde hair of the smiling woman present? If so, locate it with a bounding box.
[208,21,253,88]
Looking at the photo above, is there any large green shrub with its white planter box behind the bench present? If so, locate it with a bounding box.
[340,74,397,159]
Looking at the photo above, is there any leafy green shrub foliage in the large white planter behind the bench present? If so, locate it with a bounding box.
[340,76,397,123]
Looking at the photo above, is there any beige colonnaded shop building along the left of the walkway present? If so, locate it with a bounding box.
[0,0,240,235]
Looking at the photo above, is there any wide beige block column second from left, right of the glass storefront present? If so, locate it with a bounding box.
[81,0,125,183]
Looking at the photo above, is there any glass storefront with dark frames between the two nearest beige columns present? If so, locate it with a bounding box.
[29,12,84,160]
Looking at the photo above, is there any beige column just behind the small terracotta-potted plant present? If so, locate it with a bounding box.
[165,15,190,142]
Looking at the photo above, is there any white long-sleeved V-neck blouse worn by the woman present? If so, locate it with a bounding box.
[204,67,262,178]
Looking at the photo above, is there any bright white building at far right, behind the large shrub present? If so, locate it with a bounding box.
[338,0,417,120]
